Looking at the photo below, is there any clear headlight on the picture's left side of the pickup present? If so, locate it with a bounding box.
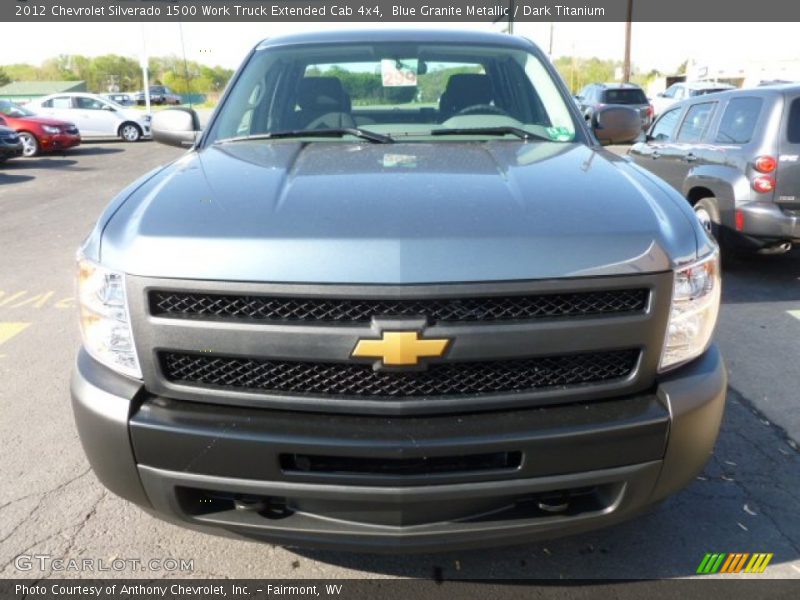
[78,257,142,379]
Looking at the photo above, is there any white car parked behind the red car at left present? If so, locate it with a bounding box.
[25,93,150,142]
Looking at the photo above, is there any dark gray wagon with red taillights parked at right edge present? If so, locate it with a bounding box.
[630,84,800,253]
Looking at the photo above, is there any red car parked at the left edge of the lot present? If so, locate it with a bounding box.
[0,100,81,156]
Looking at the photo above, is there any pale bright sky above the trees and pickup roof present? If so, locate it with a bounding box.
[0,22,800,73]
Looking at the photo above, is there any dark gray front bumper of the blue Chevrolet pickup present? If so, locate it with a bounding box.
[72,346,726,552]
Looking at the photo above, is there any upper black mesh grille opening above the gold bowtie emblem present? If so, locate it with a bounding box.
[150,289,648,323]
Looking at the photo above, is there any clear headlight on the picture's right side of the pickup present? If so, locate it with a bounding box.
[659,251,721,371]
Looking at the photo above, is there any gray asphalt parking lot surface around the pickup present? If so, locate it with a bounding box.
[0,142,800,579]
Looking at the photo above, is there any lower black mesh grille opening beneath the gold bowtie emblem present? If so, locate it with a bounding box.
[160,350,639,398]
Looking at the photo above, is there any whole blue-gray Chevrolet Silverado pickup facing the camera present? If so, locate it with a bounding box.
[72,30,726,552]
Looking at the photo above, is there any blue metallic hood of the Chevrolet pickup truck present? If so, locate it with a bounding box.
[97,140,697,283]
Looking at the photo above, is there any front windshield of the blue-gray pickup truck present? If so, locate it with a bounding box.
[206,43,575,143]
